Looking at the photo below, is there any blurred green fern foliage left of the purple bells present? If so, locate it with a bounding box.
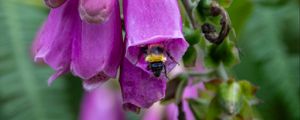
[0,0,82,120]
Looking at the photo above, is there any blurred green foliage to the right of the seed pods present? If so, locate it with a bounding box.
[232,1,300,120]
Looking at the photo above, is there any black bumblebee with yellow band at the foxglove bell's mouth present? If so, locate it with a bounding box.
[142,44,169,77]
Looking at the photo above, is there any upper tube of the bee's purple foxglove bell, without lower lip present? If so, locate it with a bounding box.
[123,0,188,71]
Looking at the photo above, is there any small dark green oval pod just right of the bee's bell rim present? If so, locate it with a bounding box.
[182,46,197,67]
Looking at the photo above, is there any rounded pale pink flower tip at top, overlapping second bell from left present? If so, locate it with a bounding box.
[79,0,115,23]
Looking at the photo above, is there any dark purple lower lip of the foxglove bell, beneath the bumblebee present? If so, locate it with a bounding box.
[120,59,166,108]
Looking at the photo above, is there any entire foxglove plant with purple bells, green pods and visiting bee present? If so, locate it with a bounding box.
[33,0,256,120]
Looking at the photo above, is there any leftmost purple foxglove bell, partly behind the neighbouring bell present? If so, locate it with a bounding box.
[33,0,81,83]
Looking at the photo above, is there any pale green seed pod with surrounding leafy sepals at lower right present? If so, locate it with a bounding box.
[187,79,257,120]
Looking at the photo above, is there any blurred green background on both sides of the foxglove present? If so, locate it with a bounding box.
[0,0,300,120]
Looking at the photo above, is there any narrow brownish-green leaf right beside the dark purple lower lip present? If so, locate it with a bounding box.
[161,74,188,104]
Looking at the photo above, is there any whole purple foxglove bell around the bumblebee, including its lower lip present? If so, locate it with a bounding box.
[120,0,188,108]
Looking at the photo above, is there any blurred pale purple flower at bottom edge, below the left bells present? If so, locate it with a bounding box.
[80,86,125,120]
